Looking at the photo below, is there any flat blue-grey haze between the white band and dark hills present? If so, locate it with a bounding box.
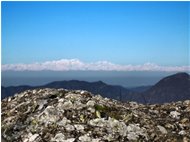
[1,71,189,88]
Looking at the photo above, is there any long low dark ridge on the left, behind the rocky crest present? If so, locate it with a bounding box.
[1,80,139,101]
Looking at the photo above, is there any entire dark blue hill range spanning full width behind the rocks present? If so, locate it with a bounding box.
[1,73,190,104]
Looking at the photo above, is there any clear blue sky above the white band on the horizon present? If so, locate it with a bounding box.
[2,2,190,66]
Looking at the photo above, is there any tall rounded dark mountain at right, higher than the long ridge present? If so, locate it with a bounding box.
[143,73,190,104]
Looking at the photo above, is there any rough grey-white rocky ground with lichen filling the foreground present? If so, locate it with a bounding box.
[1,88,190,142]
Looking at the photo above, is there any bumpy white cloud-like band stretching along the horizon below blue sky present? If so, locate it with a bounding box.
[2,59,190,72]
